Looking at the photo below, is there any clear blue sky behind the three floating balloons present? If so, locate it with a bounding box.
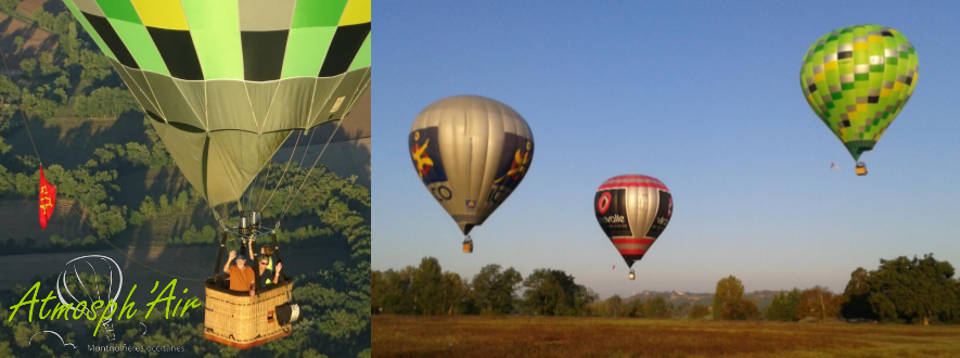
[372,1,960,297]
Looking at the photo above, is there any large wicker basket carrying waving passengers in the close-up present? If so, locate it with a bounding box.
[203,281,293,349]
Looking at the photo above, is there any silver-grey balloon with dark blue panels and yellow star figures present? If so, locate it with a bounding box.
[409,96,533,253]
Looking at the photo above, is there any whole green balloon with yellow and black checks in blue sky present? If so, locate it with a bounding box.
[800,25,917,175]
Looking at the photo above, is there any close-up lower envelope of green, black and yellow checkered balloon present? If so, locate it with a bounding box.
[65,0,370,207]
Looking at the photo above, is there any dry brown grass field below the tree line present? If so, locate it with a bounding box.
[372,315,960,358]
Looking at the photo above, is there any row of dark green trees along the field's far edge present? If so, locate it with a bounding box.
[371,254,960,324]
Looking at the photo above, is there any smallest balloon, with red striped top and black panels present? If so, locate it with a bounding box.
[593,175,673,280]
